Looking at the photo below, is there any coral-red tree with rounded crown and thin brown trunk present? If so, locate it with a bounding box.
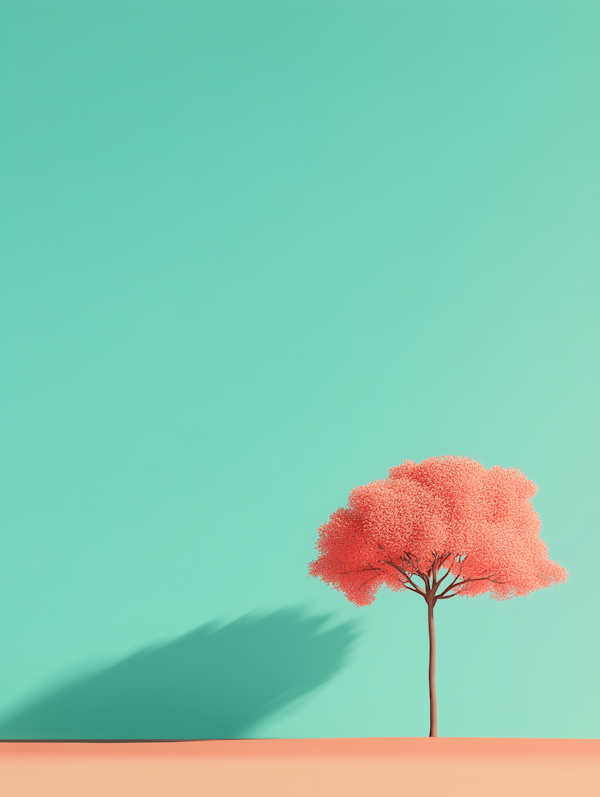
[309,457,568,736]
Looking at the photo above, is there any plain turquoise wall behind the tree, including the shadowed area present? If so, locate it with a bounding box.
[0,0,600,738]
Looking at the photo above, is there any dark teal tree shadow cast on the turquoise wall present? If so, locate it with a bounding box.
[0,608,357,740]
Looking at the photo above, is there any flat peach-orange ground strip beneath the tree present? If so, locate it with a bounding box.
[0,738,600,797]
